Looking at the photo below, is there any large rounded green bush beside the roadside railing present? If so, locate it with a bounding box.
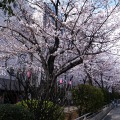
[72,84,104,115]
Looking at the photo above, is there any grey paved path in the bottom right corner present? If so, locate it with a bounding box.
[103,106,120,120]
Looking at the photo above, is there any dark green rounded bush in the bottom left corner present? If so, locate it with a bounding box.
[0,104,34,120]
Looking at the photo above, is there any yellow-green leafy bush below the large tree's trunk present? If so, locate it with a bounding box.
[17,100,65,120]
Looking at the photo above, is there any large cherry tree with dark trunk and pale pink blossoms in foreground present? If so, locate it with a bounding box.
[0,0,119,100]
